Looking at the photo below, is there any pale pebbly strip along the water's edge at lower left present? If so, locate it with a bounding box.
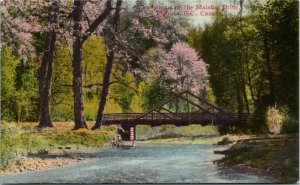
[2,148,100,174]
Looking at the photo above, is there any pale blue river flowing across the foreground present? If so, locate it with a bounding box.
[0,143,271,183]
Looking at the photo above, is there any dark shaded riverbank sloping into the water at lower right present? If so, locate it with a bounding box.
[215,135,299,183]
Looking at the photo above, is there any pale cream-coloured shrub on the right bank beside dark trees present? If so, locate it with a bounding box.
[266,107,284,134]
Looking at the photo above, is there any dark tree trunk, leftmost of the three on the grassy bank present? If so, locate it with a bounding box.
[38,1,58,127]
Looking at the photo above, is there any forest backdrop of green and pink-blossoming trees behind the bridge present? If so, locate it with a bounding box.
[1,0,299,133]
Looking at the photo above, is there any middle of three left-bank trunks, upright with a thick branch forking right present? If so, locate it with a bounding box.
[72,0,112,129]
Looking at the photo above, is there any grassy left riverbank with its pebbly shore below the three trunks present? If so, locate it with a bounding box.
[0,122,116,174]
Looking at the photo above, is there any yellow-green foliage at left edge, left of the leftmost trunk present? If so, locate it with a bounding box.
[1,48,39,122]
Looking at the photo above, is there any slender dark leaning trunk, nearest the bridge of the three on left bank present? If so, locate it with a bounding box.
[92,0,122,130]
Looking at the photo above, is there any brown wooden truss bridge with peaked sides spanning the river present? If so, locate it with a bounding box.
[103,91,249,127]
